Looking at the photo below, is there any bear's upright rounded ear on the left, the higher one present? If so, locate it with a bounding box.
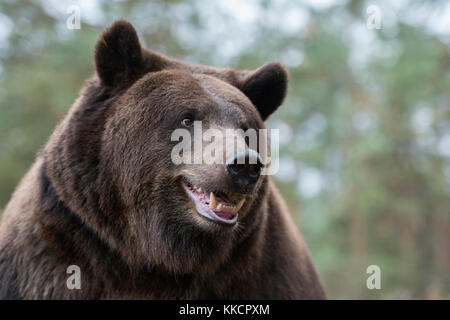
[95,20,143,86]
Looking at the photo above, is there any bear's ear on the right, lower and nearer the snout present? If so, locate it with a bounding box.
[240,62,288,121]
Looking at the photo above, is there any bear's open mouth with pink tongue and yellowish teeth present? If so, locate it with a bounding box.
[181,178,245,225]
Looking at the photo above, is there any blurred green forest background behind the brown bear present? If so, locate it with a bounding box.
[0,0,450,299]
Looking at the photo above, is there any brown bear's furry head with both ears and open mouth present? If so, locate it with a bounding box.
[44,20,287,274]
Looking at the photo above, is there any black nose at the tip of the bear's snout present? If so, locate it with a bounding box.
[225,149,263,187]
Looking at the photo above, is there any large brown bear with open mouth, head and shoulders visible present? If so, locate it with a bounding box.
[0,20,325,299]
